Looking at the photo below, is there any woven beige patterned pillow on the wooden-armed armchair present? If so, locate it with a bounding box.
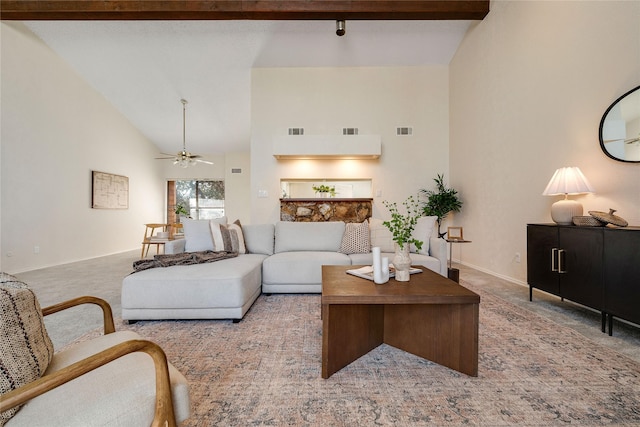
[0,273,53,425]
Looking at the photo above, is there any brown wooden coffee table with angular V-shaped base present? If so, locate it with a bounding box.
[322,265,480,378]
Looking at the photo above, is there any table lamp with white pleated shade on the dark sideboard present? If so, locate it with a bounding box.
[542,167,595,225]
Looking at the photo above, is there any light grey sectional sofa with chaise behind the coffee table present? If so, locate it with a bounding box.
[122,217,447,321]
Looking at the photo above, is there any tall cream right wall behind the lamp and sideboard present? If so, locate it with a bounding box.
[450,1,640,282]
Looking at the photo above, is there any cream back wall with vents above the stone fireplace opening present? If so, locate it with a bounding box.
[250,66,449,223]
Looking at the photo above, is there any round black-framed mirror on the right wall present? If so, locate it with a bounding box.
[600,86,640,163]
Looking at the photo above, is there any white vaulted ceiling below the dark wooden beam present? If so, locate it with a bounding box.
[25,21,476,155]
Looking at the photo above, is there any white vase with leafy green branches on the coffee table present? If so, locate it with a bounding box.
[382,196,422,282]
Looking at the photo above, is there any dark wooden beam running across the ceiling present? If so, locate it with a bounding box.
[0,0,489,21]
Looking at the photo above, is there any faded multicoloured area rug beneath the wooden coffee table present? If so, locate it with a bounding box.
[119,285,640,426]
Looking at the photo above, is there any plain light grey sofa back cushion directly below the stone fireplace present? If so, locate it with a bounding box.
[275,221,345,253]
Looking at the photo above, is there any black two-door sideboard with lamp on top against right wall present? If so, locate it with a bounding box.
[527,224,640,335]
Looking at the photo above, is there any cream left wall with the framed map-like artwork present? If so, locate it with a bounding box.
[0,23,165,273]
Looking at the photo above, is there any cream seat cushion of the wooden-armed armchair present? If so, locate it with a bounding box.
[7,331,190,427]
